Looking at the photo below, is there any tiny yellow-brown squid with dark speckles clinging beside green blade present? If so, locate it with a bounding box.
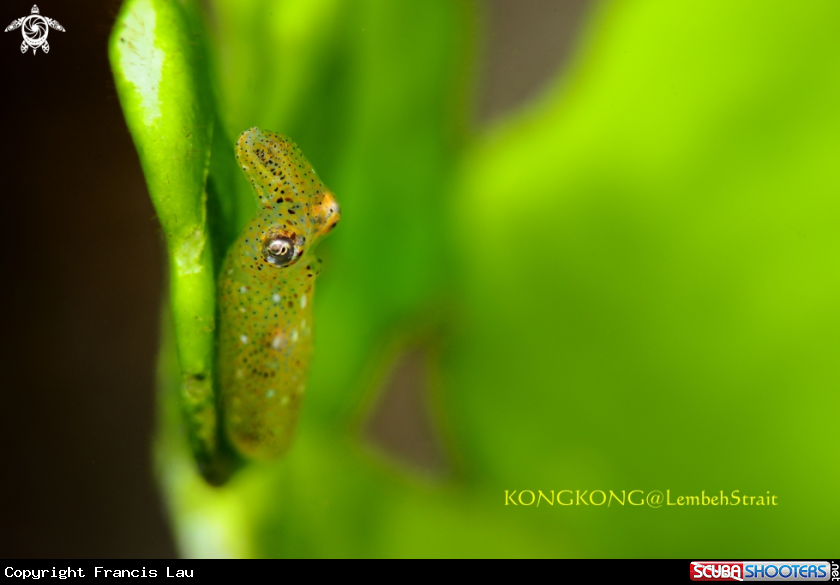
[218,128,339,459]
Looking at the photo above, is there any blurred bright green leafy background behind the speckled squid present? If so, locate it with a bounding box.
[3,0,840,558]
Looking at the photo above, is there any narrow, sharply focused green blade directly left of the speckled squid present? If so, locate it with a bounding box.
[109,0,226,475]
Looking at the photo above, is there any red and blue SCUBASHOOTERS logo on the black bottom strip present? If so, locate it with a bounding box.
[691,561,837,581]
